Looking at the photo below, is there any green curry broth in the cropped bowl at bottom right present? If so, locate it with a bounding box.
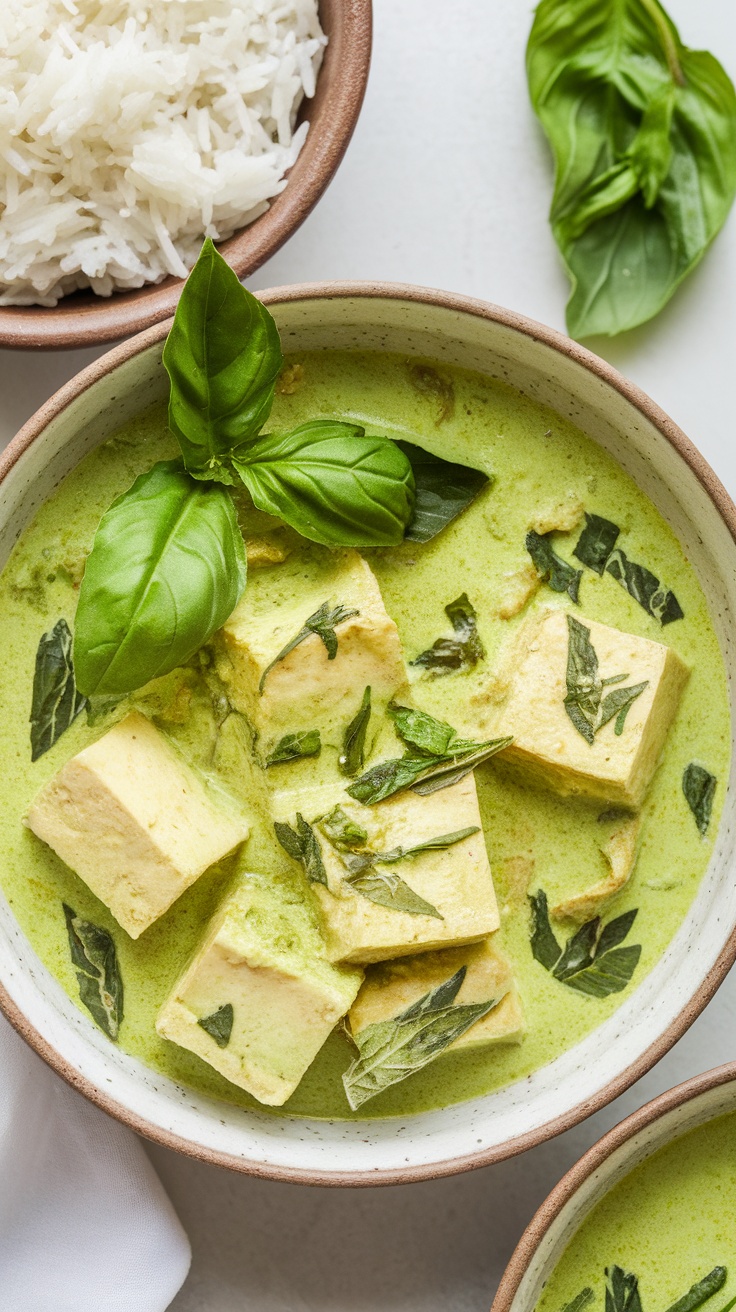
[537,1114,736,1312]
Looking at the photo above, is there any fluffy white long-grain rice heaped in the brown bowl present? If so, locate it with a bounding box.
[0,0,327,306]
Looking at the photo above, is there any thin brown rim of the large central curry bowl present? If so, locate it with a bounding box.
[0,281,736,1191]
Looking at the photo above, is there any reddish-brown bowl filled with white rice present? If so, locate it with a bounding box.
[0,0,371,349]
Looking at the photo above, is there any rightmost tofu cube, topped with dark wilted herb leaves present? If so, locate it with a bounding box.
[493,609,690,810]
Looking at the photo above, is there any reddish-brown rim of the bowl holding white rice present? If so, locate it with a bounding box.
[0,0,373,350]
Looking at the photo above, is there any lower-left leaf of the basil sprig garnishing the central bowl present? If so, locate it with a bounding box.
[73,461,245,697]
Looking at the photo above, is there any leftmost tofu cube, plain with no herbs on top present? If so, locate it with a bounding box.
[26,711,248,938]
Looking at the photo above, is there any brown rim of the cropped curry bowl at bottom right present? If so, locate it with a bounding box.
[491,1061,736,1312]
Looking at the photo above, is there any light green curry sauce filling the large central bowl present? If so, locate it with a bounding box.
[0,352,729,1118]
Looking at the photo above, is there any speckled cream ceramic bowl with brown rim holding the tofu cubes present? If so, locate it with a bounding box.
[0,283,736,1185]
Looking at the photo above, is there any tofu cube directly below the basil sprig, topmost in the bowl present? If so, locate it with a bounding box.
[216,550,407,743]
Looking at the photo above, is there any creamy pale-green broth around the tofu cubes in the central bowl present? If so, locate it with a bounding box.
[0,352,729,1118]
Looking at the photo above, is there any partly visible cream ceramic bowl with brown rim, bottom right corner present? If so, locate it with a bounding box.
[491,1061,736,1312]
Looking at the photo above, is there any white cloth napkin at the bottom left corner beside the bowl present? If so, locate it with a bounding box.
[0,1015,192,1312]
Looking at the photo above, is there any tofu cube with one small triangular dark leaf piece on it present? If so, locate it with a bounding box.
[156,875,363,1107]
